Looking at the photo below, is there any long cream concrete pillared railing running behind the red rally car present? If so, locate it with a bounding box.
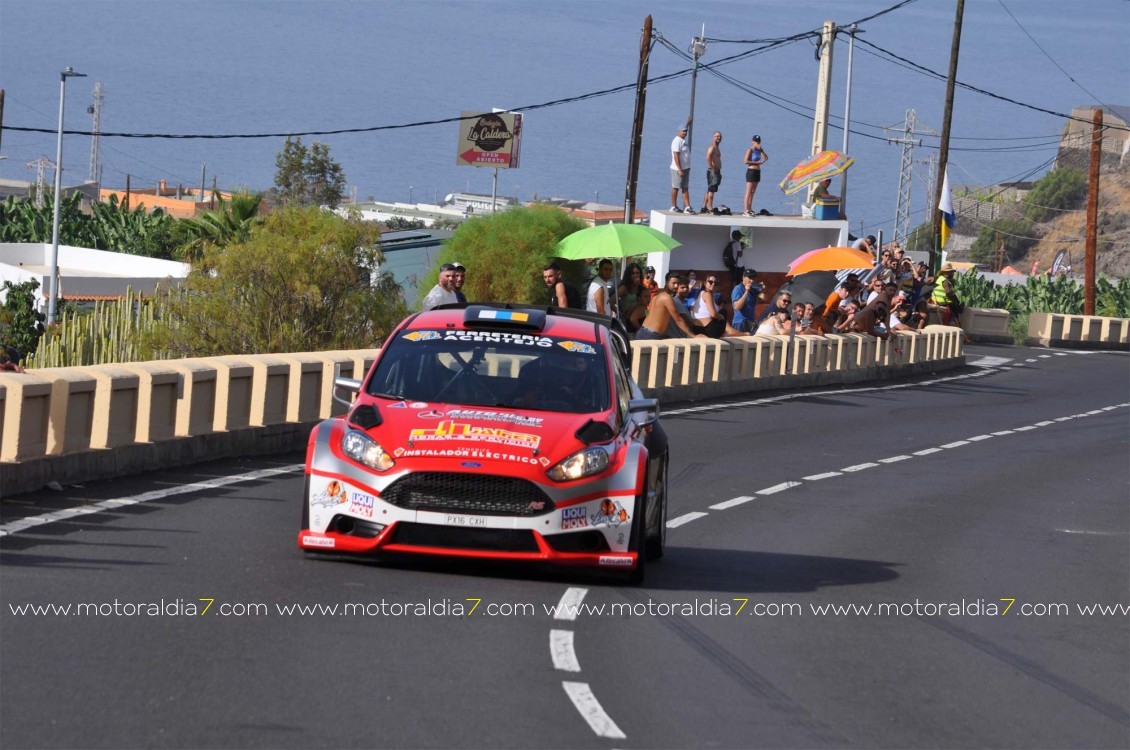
[0,325,971,494]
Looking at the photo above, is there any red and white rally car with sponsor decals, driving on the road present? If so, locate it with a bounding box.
[298,305,668,583]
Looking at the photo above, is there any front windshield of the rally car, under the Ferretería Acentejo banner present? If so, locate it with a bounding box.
[367,330,610,413]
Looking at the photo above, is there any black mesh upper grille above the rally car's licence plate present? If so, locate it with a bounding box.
[381,471,555,516]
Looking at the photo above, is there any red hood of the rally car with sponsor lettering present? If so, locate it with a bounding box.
[368,401,610,468]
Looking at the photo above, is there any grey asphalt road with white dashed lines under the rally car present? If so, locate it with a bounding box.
[0,347,1130,748]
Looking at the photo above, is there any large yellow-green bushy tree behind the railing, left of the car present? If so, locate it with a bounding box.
[150,207,407,357]
